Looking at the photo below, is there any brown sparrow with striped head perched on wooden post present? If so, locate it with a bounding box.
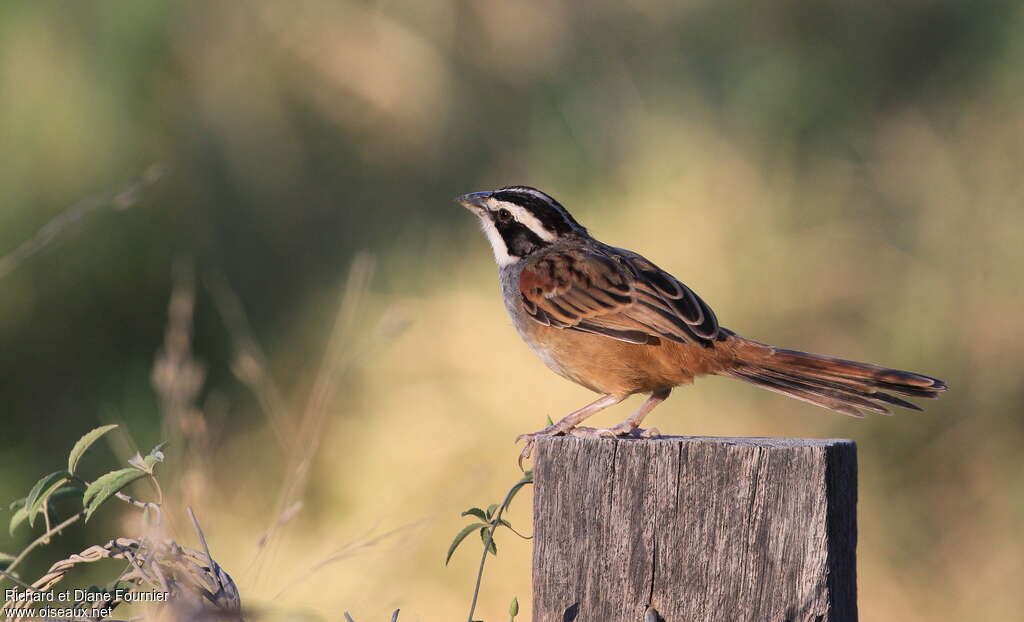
[456,185,947,467]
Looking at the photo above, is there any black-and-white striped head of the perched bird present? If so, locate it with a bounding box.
[456,185,587,266]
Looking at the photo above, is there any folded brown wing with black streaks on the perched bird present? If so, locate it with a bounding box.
[519,247,719,345]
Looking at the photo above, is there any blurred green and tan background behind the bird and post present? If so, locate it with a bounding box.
[0,0,1024,622]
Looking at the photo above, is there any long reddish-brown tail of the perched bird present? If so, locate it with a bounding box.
[718,335,946,417]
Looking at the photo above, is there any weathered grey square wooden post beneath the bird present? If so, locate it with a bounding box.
[534,437,857,622]
